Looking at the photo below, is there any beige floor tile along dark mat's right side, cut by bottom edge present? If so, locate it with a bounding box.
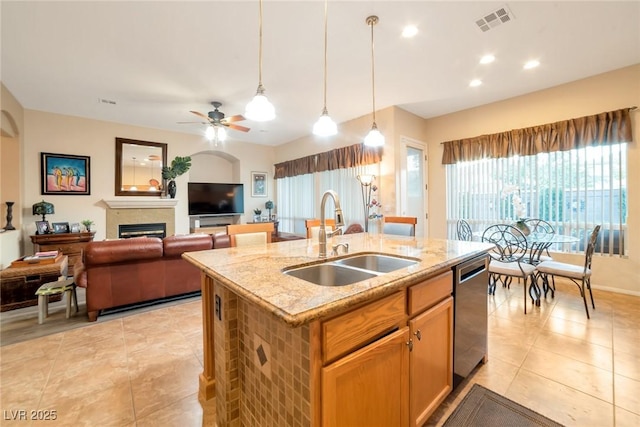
[505,369,613,427]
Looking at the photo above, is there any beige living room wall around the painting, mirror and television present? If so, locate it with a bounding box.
[17,110,274,241]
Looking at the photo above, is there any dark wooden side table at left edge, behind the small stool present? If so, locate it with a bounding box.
[0,255,69,311]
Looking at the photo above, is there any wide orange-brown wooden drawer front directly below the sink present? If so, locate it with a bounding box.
[322,291,406,364]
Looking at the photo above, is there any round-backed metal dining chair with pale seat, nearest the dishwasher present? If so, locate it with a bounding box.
[482,224,540,314]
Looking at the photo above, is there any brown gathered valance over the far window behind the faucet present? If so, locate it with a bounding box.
[274,144,382,179]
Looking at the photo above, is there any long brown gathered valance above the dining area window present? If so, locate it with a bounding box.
[442,108,632,165]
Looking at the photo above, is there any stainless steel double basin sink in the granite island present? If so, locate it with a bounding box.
[283,253,420,286]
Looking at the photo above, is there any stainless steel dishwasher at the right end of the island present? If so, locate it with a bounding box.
[453,254,489,388]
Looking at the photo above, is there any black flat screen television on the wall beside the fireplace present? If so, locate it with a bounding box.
[188,182,244,215]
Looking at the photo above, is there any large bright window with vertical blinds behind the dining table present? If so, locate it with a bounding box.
[446,143,627,256]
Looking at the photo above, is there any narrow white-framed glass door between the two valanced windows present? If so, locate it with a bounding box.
[398,137,429,237]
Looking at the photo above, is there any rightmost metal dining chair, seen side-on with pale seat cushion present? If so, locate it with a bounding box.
[537,225,600,319]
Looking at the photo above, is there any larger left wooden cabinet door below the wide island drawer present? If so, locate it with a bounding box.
[322,327,409,427]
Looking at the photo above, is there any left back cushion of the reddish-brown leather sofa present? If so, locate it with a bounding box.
[84,237,162,268]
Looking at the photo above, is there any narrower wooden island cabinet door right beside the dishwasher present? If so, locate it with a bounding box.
[409,297,453,426]
